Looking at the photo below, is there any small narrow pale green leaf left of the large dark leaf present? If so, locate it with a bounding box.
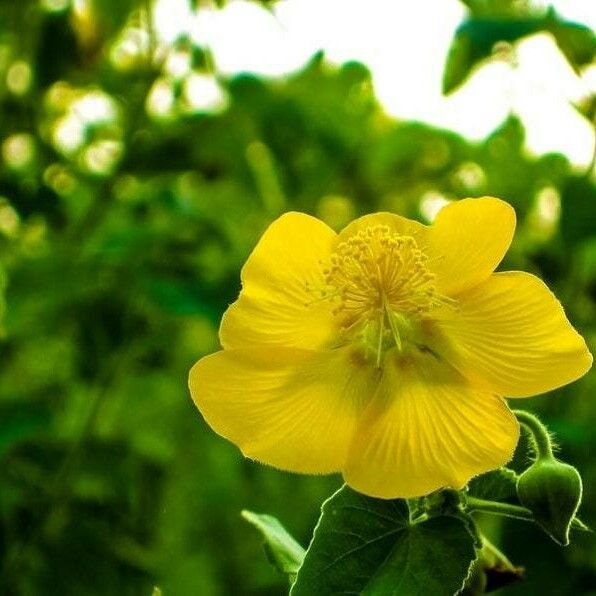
[242,510,304,576]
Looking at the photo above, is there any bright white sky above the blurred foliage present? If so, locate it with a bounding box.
[155,0,596,167]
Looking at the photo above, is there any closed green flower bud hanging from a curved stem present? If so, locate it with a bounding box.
[517,457,582,546]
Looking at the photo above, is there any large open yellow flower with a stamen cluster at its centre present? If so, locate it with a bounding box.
[190,198,592,498]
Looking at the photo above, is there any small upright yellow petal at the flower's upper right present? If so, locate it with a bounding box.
[429,197,515,296]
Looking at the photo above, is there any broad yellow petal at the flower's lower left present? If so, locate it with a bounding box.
[189,347,378,474]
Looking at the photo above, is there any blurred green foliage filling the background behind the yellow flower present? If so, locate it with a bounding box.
[0,0,596,596]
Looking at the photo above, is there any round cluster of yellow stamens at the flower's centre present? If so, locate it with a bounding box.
[314,225,448,366]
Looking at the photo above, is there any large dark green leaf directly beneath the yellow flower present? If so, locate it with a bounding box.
[291,486,476,596]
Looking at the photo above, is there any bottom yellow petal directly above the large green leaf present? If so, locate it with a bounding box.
[344,355,519,499]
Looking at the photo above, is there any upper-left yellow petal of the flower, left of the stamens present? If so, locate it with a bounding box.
[219,212,336,349]
